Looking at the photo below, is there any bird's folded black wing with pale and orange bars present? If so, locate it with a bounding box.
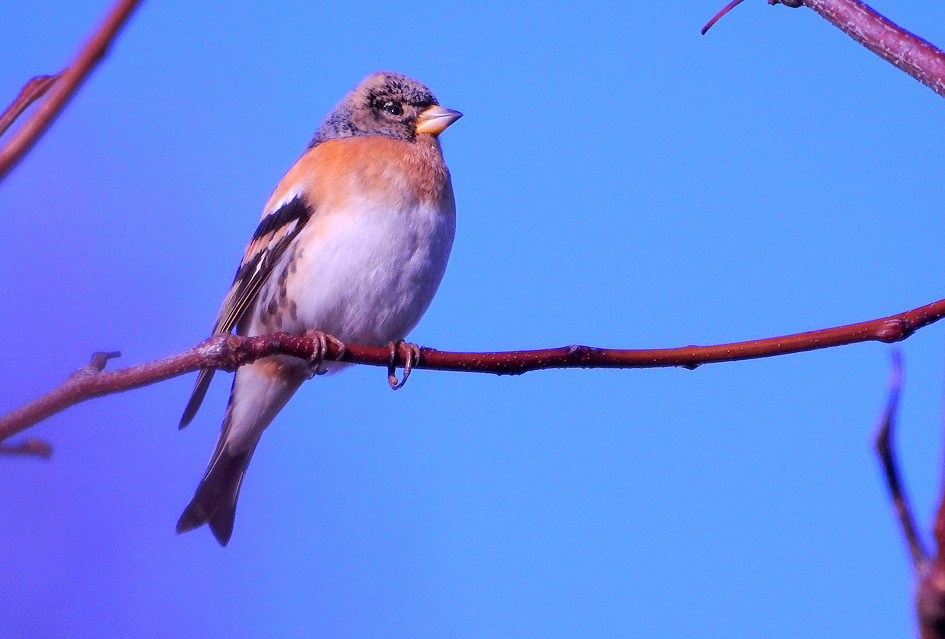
[179,193,313,428]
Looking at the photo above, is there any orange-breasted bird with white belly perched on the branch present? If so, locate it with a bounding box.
[177,71,462,546]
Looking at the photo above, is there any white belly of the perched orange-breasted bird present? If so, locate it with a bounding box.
[249,202,456,346]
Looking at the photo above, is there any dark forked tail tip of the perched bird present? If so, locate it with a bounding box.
[177,445,256,546]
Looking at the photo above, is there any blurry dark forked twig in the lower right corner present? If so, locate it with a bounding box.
[876,352,945,639]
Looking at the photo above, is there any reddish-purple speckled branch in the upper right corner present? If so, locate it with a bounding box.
[702,0,945,97]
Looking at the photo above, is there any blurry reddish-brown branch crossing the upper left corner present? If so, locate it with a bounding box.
[0,0,141,180]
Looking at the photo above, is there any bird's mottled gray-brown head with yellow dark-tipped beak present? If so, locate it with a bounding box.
[309,71,462,148]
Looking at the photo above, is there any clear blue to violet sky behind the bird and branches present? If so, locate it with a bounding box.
[0,0,945,639]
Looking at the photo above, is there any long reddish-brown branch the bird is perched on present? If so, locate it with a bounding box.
[0,300,945,450]
